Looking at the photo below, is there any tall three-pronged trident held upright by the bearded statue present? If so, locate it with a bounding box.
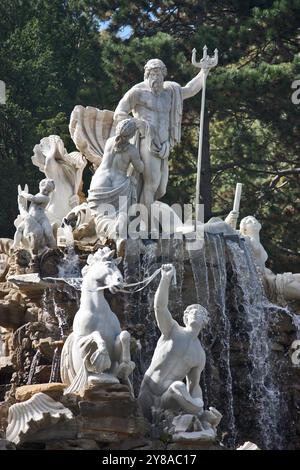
[192,46,218,220]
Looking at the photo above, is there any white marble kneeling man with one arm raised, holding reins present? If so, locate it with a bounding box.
[138,264,220,438]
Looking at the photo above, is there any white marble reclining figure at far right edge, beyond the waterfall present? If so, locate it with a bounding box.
[240,216,300,305]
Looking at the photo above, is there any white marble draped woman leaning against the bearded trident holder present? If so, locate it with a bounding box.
[88,119,144,244]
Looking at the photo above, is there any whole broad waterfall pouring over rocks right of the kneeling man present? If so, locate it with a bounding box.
[189,233,290,449]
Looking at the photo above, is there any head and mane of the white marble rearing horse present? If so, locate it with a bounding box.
[82,247,124,294]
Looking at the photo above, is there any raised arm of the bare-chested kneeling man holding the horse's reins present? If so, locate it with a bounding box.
[154,264,176,335]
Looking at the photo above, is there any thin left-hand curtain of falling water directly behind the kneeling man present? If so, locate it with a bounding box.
[189,234,236,447]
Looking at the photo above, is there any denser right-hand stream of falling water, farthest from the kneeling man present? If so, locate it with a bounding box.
[226,239,283,449]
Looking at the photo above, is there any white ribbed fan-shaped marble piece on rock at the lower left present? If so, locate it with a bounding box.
[6,392,73,445]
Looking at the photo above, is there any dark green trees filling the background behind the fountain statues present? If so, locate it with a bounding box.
[0,0,300,272]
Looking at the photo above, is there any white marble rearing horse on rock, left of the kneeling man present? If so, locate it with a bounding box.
[61,247,135,396]
